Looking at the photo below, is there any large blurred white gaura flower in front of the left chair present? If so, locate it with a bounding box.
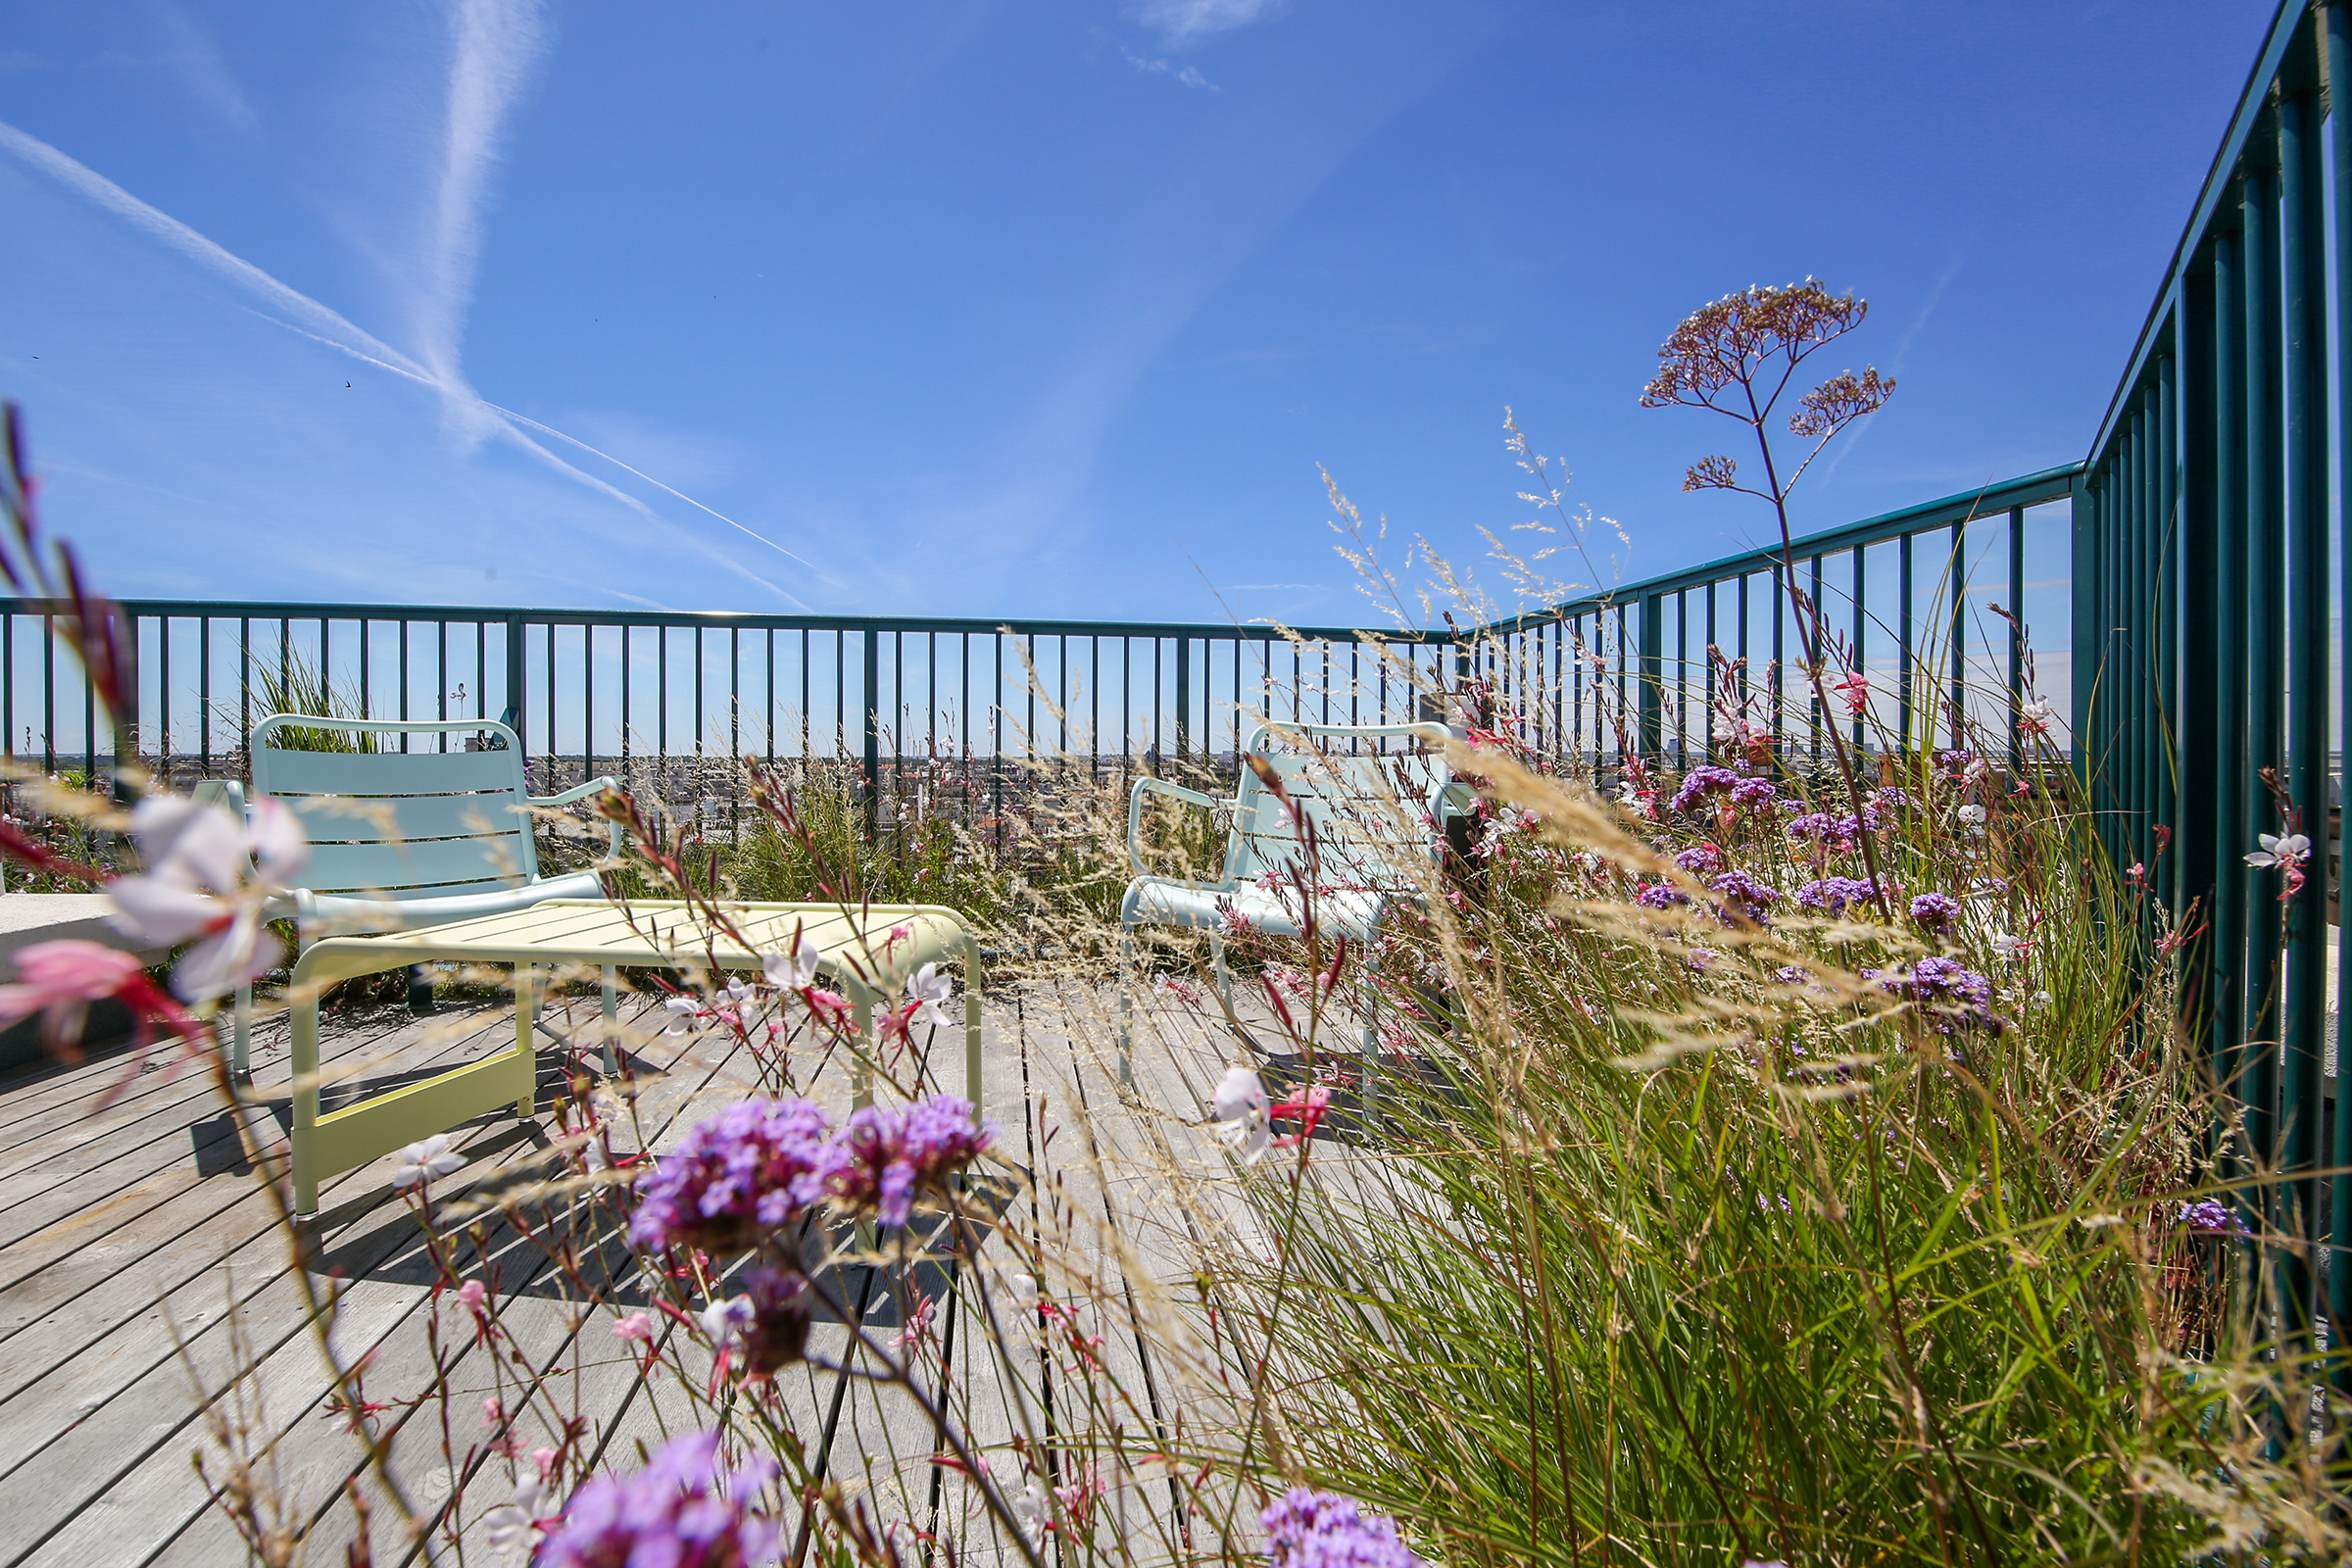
[106,795,311,1002]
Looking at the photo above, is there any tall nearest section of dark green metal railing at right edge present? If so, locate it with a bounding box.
[2075,0,2352,1326]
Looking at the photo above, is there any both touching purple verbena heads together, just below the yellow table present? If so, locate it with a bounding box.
[628,1096,998,1253]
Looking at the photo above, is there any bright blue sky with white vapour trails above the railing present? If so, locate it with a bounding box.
[0,0,2272,623]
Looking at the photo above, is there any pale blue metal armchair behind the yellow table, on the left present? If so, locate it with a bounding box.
[219,712,621,1081]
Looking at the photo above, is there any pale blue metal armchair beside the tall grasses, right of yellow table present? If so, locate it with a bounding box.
[1119,721,1468,1096]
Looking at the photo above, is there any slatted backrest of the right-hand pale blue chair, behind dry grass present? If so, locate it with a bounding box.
[1225,724,1448,894]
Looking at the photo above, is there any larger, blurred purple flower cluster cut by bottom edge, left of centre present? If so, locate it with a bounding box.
[534,1432,783,1568]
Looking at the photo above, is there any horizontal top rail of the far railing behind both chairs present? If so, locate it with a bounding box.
[0,597,1456,644]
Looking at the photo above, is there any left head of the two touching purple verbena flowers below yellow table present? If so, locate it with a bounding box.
[628,1101,847,1253]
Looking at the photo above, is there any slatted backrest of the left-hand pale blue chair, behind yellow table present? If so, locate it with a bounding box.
[252,712,539,901]
